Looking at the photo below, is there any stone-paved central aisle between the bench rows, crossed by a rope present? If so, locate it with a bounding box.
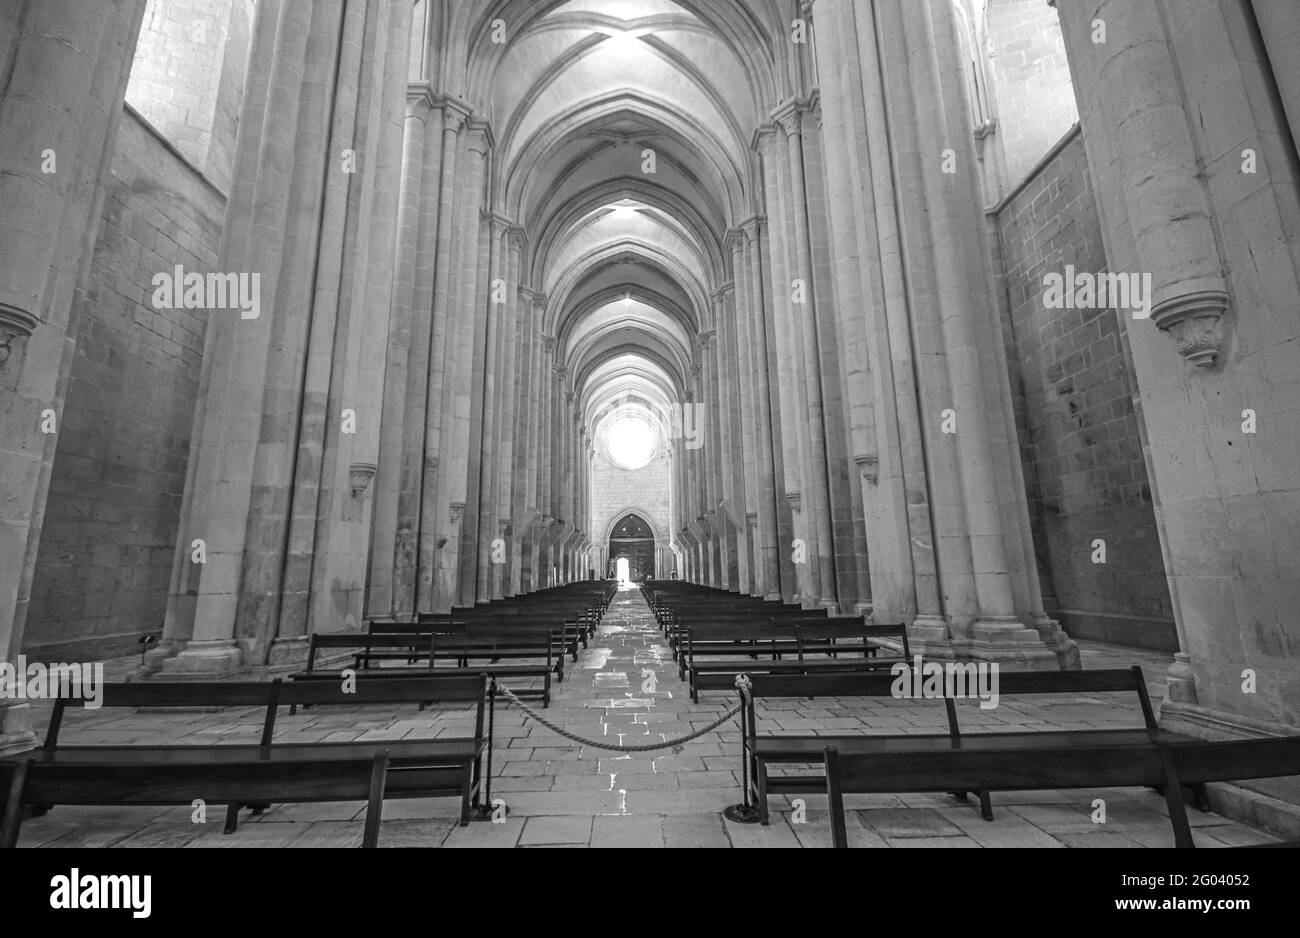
[462,587,769,846]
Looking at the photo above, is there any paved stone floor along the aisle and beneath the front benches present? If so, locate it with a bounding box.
[10,591,1273,847]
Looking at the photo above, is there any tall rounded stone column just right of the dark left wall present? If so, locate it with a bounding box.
[164,3,312,672]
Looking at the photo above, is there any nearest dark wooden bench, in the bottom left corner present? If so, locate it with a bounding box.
[0,746,389,848]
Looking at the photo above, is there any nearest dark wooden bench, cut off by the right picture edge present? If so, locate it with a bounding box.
[823,733,1300,848]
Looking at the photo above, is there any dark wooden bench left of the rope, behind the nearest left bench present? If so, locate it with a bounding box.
[30,670,491,833]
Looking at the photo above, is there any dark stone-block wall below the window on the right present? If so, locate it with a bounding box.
[997,131,1178,651]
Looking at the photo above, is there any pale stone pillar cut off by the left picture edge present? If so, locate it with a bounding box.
[0,0,144,754]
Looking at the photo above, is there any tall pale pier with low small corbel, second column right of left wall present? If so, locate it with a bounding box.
[304,0,412,639]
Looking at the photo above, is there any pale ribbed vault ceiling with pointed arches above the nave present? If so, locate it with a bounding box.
[434,0,793,438]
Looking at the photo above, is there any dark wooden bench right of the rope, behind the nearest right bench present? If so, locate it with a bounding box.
[742,666,1190,824]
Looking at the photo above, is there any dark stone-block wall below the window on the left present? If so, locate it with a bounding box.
[22,108,225,660]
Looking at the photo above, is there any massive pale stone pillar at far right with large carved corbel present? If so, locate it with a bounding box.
[1058,0,1300,722]
